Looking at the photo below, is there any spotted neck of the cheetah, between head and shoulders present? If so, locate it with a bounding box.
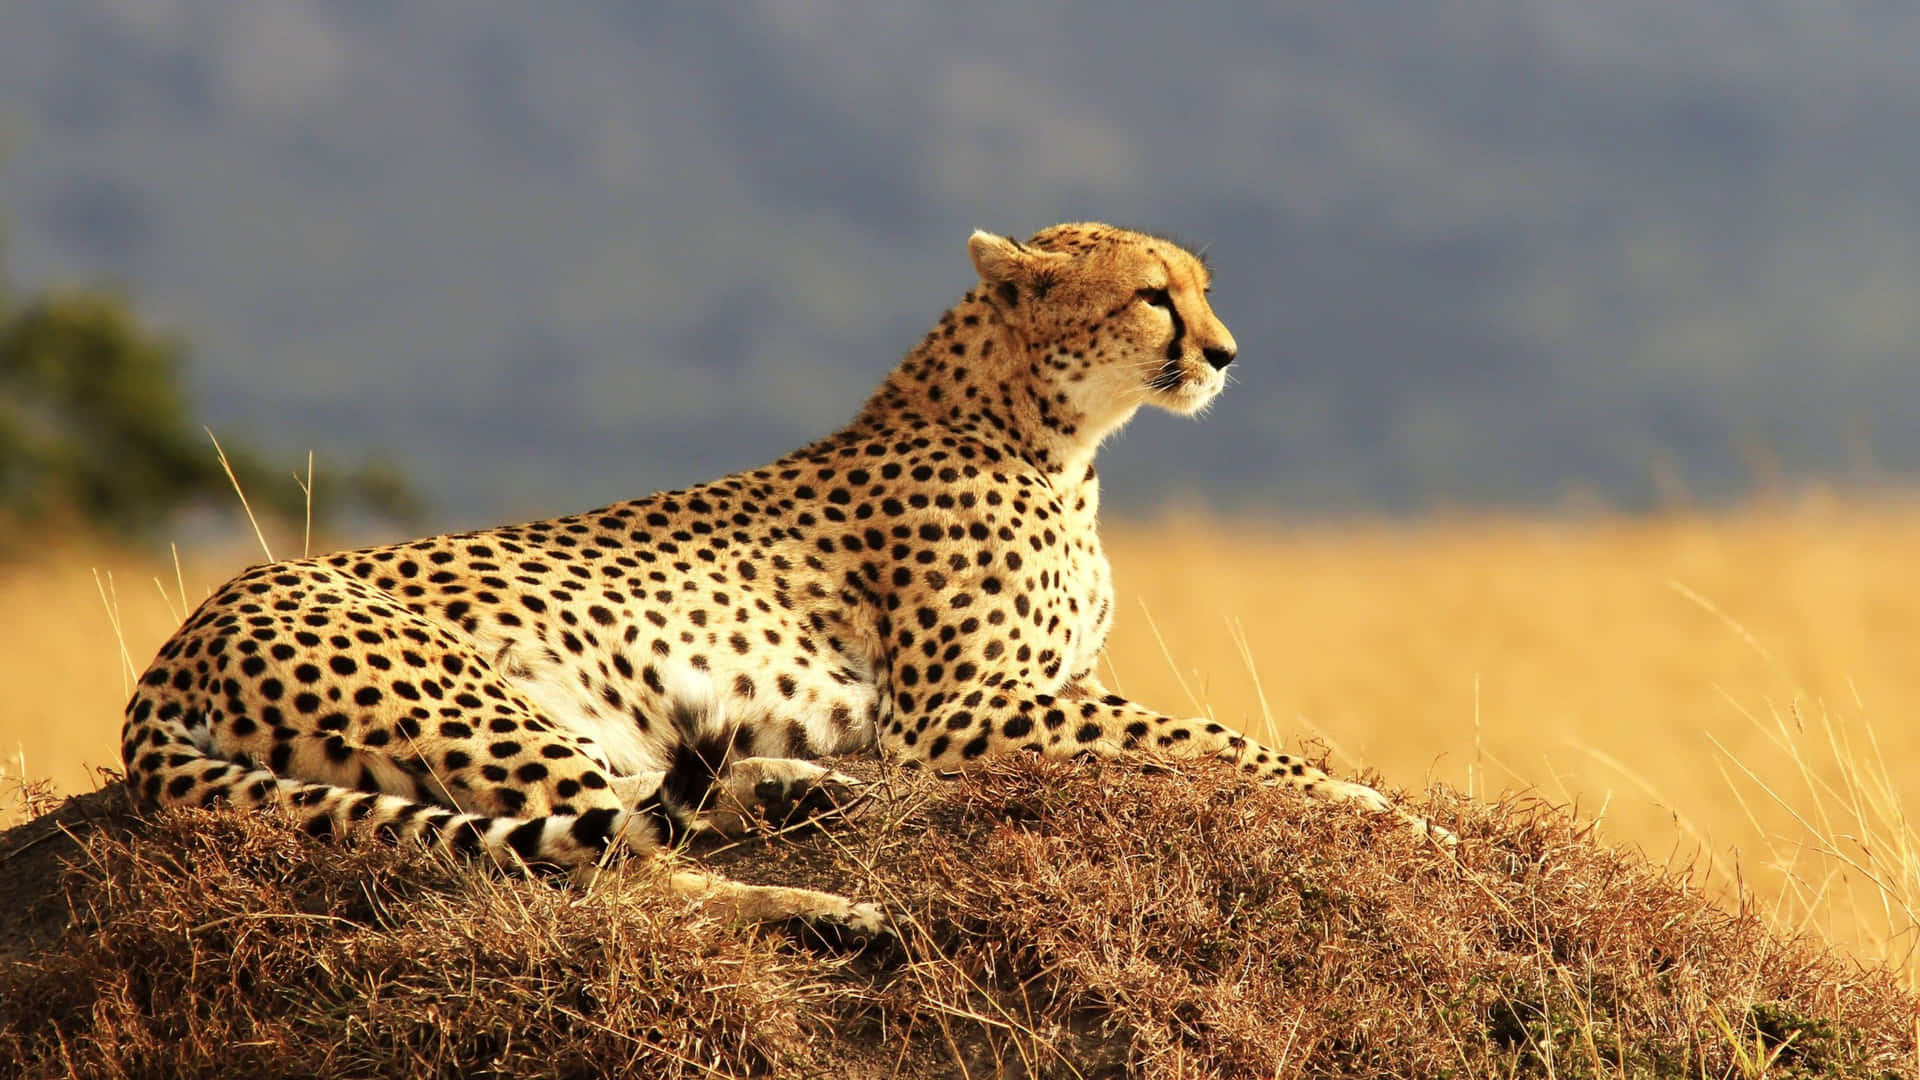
[849,290,1137,480]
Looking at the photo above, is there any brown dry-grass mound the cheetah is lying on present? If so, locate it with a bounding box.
[0,761,1920,1078]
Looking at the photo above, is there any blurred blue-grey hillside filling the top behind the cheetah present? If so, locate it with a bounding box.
[0,0,1920,521]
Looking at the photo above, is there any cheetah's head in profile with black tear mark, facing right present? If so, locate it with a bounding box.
[968,223,1236,422]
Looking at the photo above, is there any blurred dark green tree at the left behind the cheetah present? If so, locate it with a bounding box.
[0,270,419,536]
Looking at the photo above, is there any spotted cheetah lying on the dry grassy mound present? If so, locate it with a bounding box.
[123,223,1442,930]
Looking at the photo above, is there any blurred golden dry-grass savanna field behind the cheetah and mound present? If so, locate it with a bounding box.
[0,498,1920,984]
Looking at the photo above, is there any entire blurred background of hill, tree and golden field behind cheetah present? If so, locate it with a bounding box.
[11,0,1920,986]
